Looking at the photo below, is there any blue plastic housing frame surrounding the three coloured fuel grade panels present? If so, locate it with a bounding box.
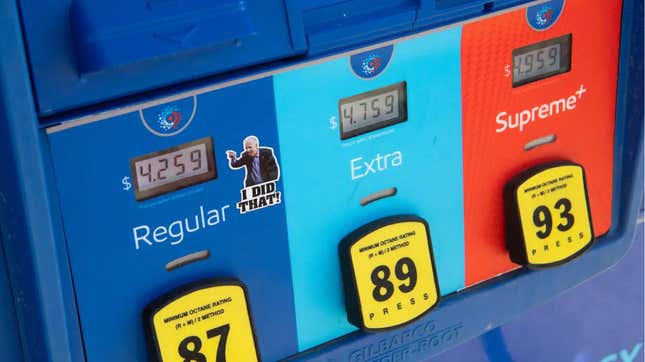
[0,0,643,361]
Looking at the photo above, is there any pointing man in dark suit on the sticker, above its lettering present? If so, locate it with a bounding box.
[226,136,280,187]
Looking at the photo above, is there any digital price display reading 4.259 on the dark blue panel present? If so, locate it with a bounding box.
[130,137,217,201]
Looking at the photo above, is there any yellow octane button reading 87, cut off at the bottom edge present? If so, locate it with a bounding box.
[144,280,259,362]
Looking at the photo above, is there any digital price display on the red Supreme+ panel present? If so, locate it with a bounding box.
[513,34,571,88]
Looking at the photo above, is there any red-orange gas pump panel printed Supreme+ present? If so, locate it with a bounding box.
[462,1,620,286]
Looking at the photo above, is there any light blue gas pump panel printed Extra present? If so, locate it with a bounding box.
[274,28,464,350]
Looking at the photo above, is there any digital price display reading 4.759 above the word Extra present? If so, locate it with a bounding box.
[338,82,408,140]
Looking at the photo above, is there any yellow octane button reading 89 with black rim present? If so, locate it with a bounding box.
[339,216,441,331]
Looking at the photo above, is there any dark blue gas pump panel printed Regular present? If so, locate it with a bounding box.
[50,79,297,361]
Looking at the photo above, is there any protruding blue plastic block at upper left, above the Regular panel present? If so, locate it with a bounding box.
[70,0,254,73]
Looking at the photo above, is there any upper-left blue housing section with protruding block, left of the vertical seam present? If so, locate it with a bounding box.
[19,0,306,115]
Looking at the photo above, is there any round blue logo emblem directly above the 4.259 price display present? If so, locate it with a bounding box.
[139,96,197,137]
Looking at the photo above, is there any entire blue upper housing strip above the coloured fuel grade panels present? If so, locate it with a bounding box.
[18,0,534,116]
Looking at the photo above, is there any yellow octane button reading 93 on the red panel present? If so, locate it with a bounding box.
[505,162,594,267]
